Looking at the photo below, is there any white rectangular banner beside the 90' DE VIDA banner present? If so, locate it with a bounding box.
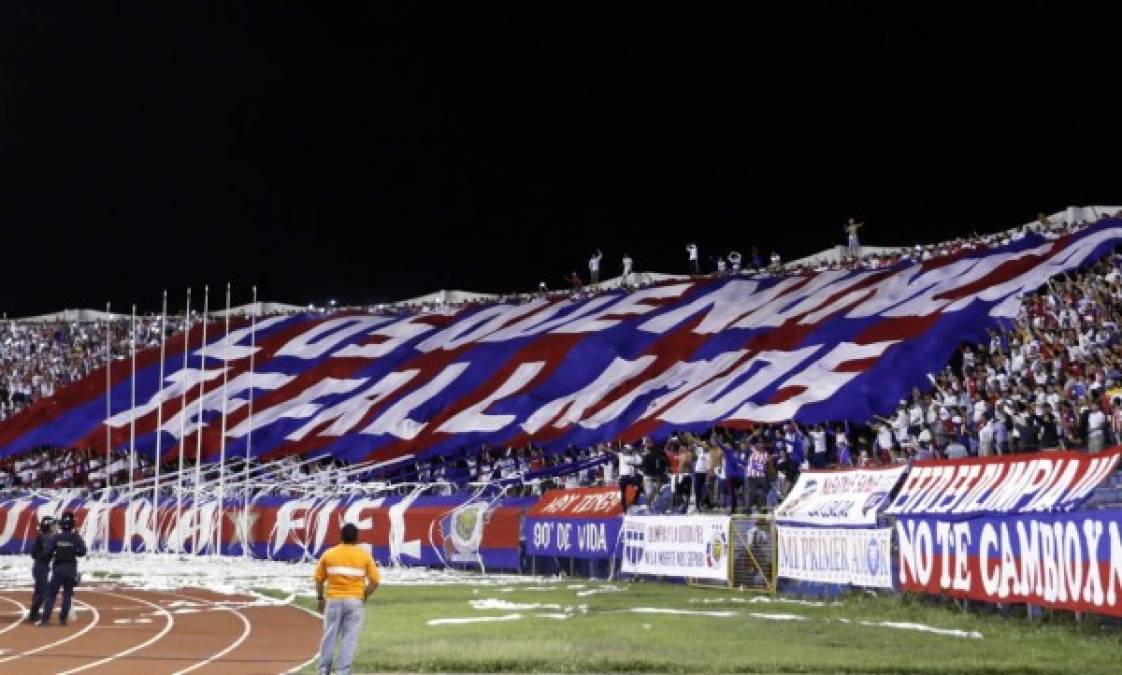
[622,516,729,581]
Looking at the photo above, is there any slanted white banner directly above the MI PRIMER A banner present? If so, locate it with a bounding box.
[775,464,908,527]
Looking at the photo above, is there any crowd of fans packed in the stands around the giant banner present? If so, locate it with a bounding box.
[0,205,1122,504]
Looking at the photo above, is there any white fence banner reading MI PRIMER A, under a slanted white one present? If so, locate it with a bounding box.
[778,525,892,589]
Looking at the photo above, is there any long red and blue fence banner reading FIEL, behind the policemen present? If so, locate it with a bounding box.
[0,488,535,571]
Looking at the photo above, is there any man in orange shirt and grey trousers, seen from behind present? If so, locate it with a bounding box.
[315,523,381,675]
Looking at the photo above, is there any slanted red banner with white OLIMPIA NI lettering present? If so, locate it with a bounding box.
[884,449,1122,519]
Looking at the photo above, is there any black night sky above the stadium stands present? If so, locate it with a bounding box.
[0,1,1122,315]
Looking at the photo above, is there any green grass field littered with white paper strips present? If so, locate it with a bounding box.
[284,580,1122,674]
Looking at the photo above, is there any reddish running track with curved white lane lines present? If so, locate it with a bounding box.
[0,585,321,675]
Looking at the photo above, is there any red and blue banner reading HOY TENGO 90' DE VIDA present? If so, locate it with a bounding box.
[522,487,634,558]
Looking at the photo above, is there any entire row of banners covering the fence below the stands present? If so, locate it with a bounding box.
[0,449,1122,617]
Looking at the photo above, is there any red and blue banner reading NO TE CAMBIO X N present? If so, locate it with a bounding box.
[896,510,1122,617]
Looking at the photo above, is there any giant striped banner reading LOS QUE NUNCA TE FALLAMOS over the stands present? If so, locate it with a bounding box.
[0,220,1122,462]
